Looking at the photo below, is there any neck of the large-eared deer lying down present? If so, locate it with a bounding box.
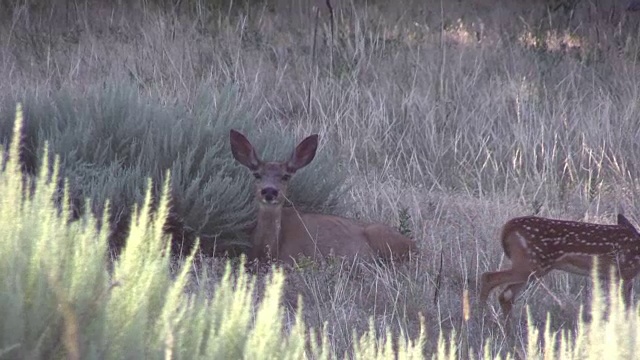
[253,205,282,258]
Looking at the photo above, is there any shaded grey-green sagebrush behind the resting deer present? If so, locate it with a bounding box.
[0,86,345,254]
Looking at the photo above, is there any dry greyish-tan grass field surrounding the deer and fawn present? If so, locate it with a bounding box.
[0,0,640,355]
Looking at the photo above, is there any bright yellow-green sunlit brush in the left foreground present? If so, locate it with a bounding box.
[0,101,430,359]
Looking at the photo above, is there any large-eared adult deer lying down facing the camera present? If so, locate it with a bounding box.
[230,129,416,265]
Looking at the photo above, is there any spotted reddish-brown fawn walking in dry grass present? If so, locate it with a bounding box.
[479,214,640,319]
